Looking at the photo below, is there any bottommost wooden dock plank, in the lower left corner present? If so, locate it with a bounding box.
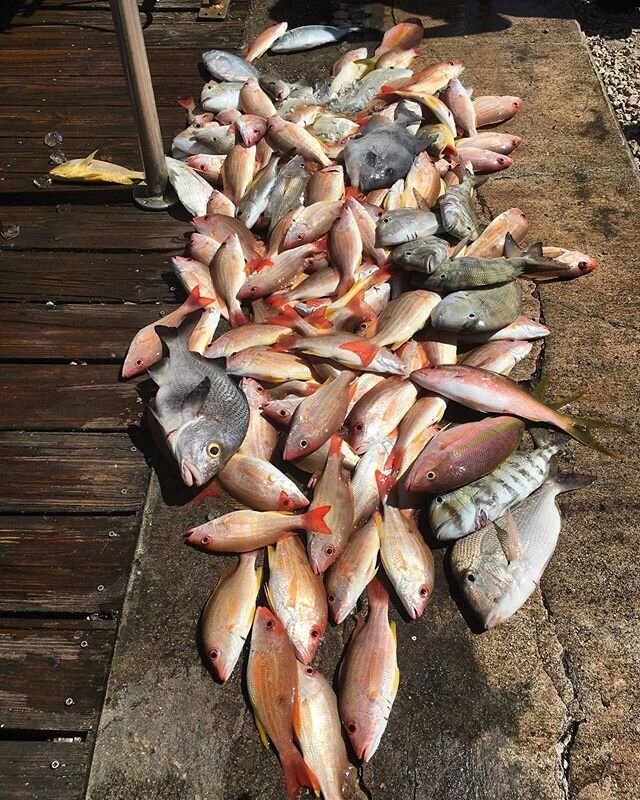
[0,741,91,800]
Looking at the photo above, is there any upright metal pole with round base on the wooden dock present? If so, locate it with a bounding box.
[109,0,176,211]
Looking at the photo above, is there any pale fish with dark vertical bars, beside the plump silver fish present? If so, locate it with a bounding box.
[429,428,570,542]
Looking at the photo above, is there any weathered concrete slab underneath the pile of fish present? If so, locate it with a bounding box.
[89,0,640,800]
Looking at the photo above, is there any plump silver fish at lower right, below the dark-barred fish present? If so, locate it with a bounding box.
[451,468,594,629]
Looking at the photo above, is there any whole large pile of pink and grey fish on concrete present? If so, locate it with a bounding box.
[124,20,610,800]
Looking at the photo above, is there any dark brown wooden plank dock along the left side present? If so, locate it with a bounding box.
[0,0,248,800]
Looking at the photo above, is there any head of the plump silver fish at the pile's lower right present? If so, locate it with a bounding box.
[451,525,518,629]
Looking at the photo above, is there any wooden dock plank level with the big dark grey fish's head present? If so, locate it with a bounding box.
[0,432,149,514]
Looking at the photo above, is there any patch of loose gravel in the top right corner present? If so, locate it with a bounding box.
[573,0,640,169]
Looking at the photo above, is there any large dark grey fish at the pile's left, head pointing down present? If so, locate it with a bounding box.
[148,314,249,486]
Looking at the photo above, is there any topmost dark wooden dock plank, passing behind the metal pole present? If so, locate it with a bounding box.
[3,7,244,48]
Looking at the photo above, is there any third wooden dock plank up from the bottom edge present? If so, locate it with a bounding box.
[0,516,139,614]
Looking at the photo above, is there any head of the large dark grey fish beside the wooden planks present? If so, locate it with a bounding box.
[169,416,246,486]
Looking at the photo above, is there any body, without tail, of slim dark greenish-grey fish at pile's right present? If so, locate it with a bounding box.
[420,256,525,294]
